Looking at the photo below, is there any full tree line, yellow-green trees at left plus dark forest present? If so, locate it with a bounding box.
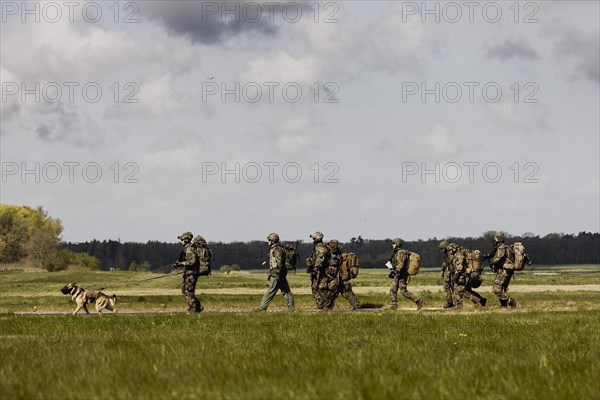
[0,204,600,272]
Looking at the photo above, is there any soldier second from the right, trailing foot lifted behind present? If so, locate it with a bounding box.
[448,243,487,309]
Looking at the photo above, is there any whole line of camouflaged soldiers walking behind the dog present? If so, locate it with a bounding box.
[173,228,531,313]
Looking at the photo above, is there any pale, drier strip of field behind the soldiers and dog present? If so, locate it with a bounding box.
[0,267,600,312]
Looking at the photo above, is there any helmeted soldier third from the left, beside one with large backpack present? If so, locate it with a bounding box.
[306,232,333,309]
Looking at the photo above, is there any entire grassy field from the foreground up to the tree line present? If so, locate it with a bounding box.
[0,266,600,399]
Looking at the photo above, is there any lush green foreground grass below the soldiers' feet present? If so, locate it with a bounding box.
[0,310,600,399]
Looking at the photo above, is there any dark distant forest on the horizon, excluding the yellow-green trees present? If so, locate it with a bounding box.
[61,231,600,272]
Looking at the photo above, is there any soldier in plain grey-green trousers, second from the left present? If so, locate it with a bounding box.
[254,233,295,311]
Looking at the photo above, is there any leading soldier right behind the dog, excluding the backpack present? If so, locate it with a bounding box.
[172,232,204,313]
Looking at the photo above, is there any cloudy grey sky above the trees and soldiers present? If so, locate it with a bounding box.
[0,0,600,242]
